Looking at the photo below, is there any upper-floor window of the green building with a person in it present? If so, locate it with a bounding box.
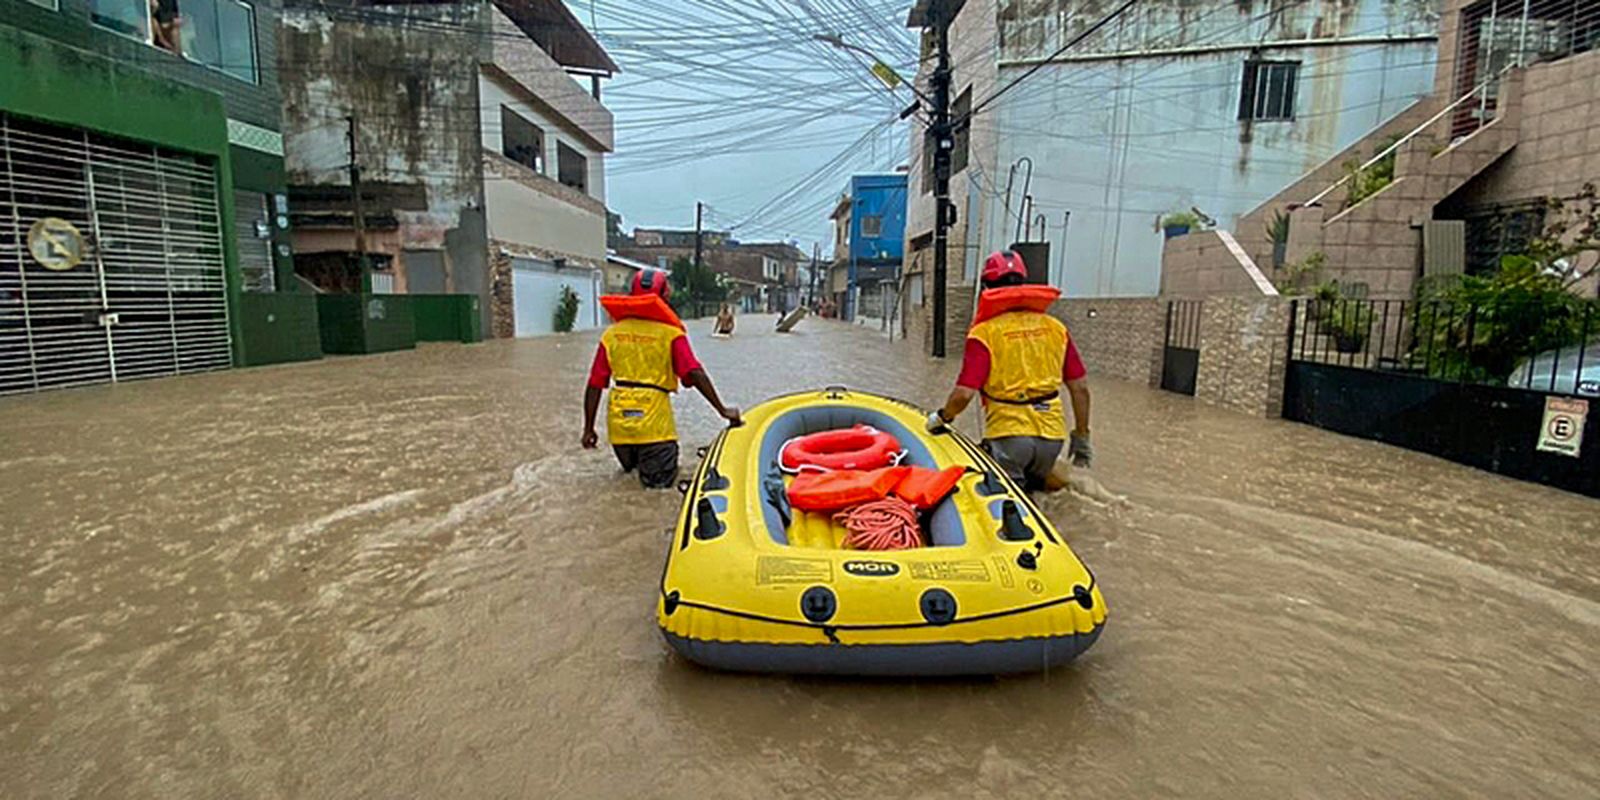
[90,0,256,83]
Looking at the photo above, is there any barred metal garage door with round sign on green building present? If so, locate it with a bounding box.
[0,114,230,394]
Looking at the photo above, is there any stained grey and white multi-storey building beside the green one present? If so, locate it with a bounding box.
[282,0,618,336]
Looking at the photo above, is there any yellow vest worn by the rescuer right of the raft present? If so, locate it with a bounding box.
[966,310,1067,440]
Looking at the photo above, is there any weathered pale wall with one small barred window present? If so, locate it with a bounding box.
[979,0,1437,296]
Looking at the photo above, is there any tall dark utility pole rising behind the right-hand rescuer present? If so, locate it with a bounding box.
[906,0,966,358]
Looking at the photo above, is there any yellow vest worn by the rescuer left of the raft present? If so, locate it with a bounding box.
[600,318,683,445]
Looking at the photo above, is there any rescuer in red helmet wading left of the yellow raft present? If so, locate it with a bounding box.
[582,270,739,488]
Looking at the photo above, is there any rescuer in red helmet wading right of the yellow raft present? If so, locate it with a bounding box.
[928,251,1094,491]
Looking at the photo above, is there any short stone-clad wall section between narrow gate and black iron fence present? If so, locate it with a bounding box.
[1195,298,1290,418]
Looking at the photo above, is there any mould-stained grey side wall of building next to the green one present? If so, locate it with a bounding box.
[280,3,490,333]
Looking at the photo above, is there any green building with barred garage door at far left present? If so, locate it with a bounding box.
[0,0,322,394]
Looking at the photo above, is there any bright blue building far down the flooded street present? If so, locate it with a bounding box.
[830,173,906,320]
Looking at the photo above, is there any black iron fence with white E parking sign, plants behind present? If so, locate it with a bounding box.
[1283,299,1600,496]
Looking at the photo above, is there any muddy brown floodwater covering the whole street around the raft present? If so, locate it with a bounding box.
[0,318,1600,798]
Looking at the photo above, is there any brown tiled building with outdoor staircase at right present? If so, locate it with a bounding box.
[1162,0,1600,299]
